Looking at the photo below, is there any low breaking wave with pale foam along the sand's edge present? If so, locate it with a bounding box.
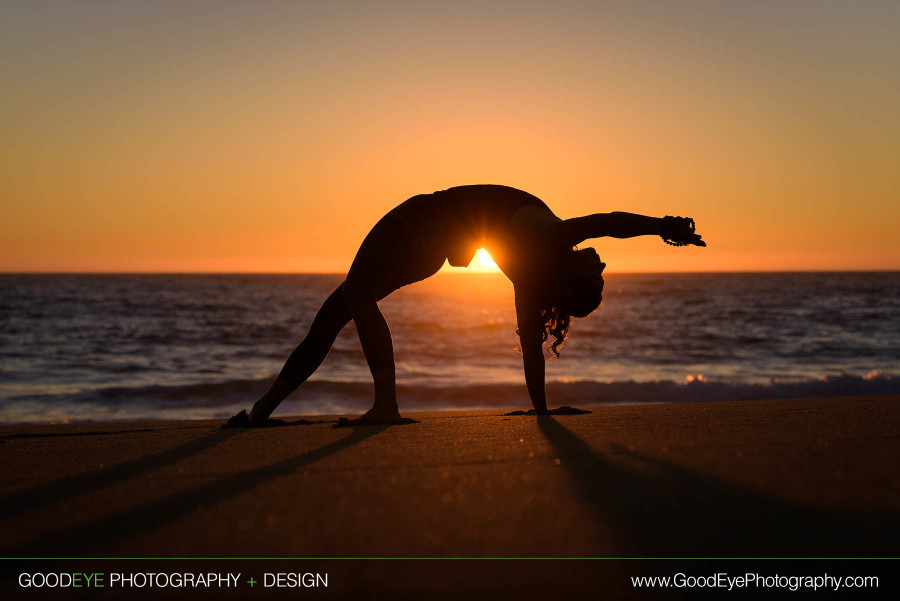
[0,371,900,423]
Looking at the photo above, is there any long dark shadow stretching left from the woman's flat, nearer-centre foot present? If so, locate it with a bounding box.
[4,426,388,557]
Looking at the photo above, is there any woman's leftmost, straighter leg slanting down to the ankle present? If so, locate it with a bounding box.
[250,284,350,425]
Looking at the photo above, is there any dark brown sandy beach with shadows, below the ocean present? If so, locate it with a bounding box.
[0,396,900,596]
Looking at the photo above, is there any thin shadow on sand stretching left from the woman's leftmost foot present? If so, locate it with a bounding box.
[0,430,240,518]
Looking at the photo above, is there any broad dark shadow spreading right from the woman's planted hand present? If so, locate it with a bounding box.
[538,417,900,557]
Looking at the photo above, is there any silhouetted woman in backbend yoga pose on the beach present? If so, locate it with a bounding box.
[226,185,706,427]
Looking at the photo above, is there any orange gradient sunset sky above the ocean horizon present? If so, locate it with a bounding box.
[0,0,900,272]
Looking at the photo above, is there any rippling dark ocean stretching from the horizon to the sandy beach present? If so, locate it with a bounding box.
[0,272,900,423]
